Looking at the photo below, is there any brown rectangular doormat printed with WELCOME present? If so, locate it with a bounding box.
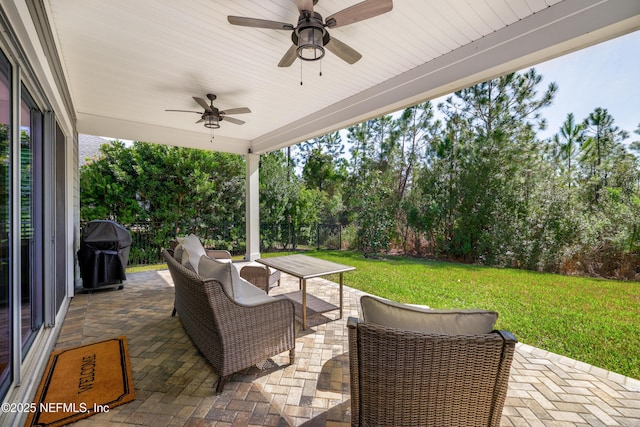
[26,336,134,427]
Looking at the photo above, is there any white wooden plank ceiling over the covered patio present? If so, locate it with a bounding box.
[45,0,640,154]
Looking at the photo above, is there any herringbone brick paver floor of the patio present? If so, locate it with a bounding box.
[51,270,640,427]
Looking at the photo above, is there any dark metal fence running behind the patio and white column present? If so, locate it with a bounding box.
[81,222,350,266]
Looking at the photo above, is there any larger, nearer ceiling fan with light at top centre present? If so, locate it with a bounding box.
[227,0,393,67]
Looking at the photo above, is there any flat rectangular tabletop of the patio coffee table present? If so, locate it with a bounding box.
[256,254,356,280]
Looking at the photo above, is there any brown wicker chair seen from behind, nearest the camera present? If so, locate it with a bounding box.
[347,318,516,426]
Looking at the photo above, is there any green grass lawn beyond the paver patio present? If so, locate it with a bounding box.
[127,251,640,379]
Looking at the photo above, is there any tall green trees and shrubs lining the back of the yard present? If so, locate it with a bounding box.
[81,68,640,278]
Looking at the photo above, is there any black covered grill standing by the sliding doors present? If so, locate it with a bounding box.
[78,220,131,289]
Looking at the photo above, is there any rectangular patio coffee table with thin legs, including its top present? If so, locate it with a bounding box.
[256,254,356,329]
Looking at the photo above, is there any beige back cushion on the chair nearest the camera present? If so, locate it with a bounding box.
[360,295,498,335]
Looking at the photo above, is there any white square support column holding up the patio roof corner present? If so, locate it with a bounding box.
[244,154,260,261]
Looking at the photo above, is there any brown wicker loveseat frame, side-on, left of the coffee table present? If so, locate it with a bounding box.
[162,249,295,393]
